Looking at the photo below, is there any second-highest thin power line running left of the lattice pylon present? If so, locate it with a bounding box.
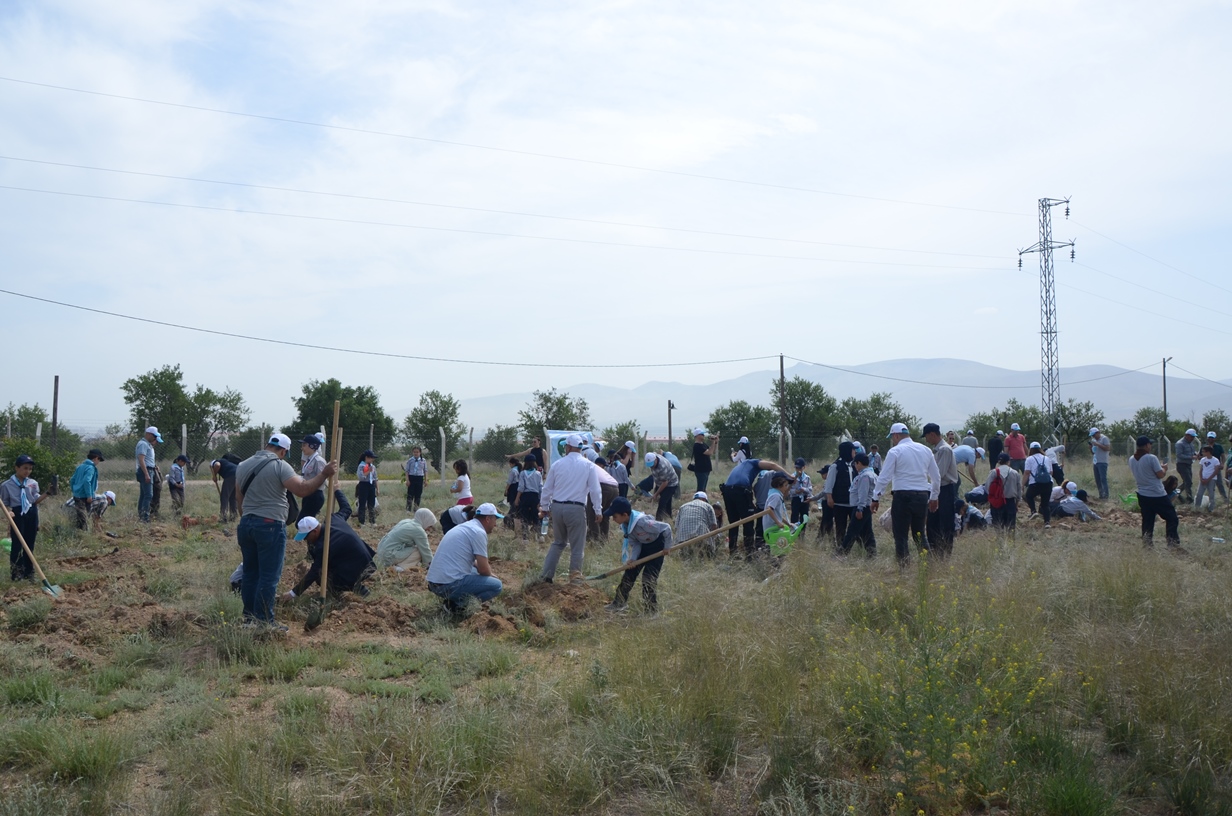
[0,155,1002,259]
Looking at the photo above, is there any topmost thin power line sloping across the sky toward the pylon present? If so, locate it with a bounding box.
[0,76,1026,217]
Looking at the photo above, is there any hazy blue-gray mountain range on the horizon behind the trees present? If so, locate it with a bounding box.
[431,359,1232,438]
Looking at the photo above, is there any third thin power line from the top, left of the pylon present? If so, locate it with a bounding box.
[0,185,1002,271]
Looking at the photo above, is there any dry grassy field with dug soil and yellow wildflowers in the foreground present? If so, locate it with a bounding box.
[0,463,1232,816]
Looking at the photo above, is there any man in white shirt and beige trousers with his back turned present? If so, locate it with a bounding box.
[537,434,604,583]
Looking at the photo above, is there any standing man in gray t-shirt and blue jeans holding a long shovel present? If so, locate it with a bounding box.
[235,434,338,630]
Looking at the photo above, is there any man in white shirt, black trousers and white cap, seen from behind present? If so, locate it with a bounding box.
[872,422,941,565]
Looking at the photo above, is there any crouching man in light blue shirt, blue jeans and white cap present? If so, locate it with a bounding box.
[428,502,505,614]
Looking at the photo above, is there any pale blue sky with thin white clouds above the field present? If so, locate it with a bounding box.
[0,0,1232,438]
